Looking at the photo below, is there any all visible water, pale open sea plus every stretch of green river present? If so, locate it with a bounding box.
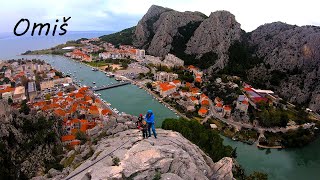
[0,32,320,180]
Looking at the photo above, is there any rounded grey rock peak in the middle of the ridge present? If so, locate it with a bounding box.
[186,11,242,69]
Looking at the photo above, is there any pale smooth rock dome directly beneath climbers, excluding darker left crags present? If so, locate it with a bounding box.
[62,129,234,180]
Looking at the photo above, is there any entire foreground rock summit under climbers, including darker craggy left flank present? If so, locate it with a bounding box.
[33,115,238,180]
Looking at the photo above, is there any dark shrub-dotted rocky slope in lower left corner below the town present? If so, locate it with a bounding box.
[0,101,62,179]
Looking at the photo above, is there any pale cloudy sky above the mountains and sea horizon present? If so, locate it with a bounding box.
[0,0,320,32]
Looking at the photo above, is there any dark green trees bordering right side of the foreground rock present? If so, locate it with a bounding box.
[162,119,233,162]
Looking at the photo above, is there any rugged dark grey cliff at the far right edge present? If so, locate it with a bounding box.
[249,22,320,111]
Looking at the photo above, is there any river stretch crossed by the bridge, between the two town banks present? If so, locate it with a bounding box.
[17,55,180,127]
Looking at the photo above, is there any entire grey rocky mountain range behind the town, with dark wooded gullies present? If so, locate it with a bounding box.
[99,5,320,112]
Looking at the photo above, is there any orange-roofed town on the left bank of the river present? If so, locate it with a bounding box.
[0,60,115,146]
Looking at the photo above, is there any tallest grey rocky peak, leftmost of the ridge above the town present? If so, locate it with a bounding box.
[133,6,205,56]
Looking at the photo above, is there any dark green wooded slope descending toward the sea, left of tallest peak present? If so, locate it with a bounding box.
[100,26,136,45]
